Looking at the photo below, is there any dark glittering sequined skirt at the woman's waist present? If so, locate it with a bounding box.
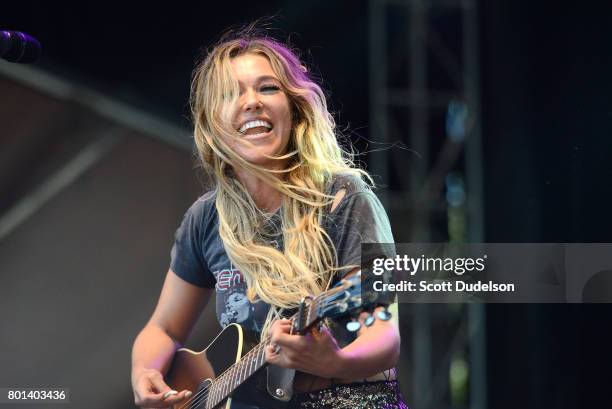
[288,381,408,409]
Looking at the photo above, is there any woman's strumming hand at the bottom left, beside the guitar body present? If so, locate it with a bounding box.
[132,369,192,409]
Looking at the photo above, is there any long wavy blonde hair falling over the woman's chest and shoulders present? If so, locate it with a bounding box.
[190,32,372,333]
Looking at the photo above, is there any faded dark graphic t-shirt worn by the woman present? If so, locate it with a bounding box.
[170,175,393,344]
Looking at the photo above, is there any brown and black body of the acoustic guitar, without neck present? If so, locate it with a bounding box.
[166,324,285,409]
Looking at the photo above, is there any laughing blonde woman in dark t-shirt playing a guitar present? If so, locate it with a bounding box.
[132,27,405,408]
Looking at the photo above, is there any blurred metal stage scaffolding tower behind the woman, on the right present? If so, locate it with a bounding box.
[368,0,487,409]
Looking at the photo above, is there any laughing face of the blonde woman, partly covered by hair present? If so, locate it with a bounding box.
[228,54,292,169]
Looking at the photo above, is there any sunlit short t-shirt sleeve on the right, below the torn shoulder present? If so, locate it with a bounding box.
[330,190,394,275]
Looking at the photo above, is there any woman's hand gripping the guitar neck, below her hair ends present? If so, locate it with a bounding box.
[266,319,347,378]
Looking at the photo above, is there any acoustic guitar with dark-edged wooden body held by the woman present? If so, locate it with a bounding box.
[167,273,375,409]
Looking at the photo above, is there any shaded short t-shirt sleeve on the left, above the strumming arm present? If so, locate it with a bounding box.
[170,202,215,288]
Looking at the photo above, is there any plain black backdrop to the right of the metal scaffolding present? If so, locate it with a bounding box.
[481,1,612,407]
